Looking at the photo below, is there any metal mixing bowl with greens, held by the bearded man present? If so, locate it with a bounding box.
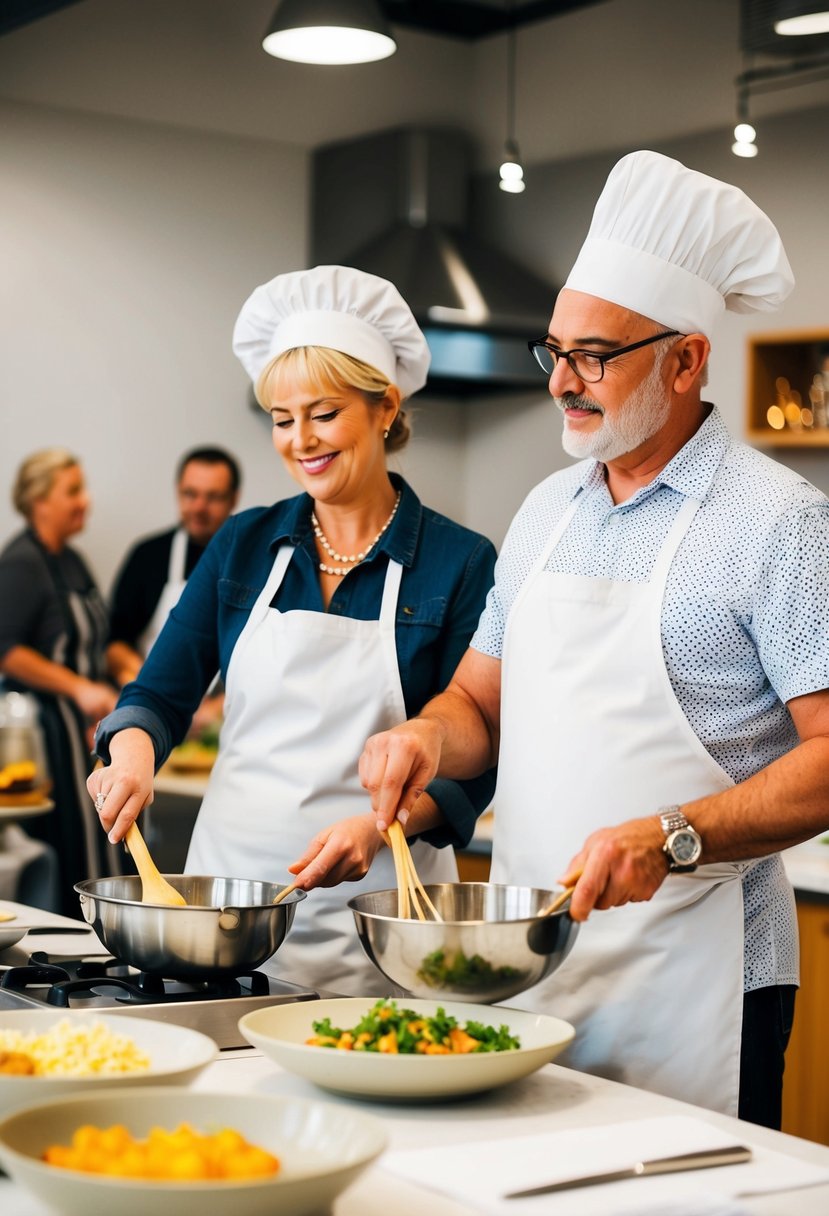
[349,883,579,1004]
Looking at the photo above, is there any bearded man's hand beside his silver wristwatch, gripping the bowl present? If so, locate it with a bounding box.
[559,815,667,921]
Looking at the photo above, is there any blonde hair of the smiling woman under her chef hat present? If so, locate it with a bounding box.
[254,347,412,452]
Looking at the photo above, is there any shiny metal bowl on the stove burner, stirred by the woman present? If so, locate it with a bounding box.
[75,874,305,980]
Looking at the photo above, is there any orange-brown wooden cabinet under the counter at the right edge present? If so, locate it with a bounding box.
[783,891,829,1144]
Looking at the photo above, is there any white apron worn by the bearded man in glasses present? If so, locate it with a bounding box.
[492,495,748,1115]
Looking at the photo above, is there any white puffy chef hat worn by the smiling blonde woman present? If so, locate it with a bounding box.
[233,266,430,396]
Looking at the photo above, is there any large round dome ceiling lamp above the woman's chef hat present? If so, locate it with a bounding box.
[263,0,397,63]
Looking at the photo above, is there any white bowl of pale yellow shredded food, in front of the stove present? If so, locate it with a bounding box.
[0,1008,219,1113]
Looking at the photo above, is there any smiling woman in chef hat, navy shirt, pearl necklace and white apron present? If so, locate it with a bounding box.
[89,266,495,995]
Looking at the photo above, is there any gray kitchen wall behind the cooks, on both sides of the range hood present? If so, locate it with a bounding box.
[0,93,829,578]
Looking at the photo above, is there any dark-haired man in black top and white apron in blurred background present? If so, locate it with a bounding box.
[107,447,241,733]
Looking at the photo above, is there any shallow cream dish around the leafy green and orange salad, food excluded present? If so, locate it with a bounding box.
[239,997,575,1102]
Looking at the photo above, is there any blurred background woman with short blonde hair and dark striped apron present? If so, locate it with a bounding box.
[0,447,117,918]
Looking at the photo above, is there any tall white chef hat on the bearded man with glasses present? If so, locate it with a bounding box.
[564,152,794,336]
